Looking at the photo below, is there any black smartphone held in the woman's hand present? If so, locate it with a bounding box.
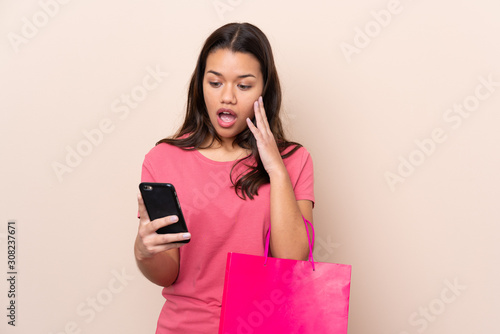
[139,182,189,243]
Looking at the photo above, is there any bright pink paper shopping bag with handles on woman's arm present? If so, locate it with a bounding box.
[219,220,351,334]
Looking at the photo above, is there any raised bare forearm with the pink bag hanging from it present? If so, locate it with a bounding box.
[269,166,312,260]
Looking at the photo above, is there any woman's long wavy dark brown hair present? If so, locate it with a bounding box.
[156,23,301,199]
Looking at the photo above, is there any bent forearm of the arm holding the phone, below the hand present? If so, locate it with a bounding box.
[134,237,179,287]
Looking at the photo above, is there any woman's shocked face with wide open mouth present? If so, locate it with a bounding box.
[203,49,264,140]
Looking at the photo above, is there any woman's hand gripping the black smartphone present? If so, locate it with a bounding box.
[135,193,191,261]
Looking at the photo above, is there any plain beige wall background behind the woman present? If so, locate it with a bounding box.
[0,0,500,334]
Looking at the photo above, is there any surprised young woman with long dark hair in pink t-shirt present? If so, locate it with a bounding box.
[134,23,314,333]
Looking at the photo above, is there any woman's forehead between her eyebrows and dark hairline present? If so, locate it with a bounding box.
[205,49,261,77]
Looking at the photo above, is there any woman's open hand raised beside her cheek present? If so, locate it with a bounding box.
[247,96,285,176]
